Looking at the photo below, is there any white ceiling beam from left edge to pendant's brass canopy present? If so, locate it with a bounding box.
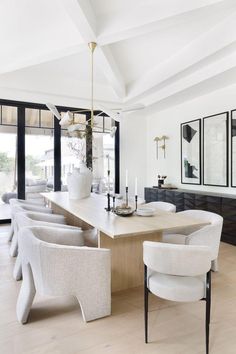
[0,44,87,75]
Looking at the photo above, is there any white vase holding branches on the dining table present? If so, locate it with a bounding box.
[67,165,93,199]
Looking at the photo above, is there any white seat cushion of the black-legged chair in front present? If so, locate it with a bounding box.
[148,271,205,302]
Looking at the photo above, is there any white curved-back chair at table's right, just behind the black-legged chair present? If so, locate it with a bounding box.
[162,210,223,271]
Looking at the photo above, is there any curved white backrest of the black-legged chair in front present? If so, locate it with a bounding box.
[143,241,211,276]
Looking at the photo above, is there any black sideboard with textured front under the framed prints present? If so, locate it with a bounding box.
[144,187,236,245]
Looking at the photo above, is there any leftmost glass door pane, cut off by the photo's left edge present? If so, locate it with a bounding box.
[0,125,17,219]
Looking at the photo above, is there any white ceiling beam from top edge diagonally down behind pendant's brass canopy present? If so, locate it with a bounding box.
[61,0,125,99]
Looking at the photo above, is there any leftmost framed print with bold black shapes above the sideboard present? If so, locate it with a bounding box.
[181,119,201,184]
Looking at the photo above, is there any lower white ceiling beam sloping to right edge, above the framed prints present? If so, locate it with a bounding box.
[126,12,236,103]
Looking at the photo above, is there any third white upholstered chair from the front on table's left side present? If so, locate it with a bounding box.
[8,198,52,242]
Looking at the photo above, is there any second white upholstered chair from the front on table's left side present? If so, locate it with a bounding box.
[13,212,85,280]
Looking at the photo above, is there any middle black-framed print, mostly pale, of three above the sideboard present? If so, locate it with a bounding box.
[203,112,229,187]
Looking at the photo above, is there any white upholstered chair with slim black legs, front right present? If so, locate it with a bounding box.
[143,241,211,354]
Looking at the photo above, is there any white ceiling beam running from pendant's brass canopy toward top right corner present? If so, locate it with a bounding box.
[98,0,227,45]
